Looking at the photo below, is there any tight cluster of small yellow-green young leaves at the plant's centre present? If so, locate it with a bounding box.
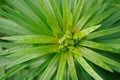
[59,31,80,53]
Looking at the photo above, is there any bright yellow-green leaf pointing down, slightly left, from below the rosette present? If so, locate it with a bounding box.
[56,53,67,80]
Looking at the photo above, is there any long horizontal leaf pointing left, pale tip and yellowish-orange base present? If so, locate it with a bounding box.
[0,35,58,43]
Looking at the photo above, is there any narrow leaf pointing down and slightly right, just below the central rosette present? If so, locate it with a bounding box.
[67,54,78,80]
